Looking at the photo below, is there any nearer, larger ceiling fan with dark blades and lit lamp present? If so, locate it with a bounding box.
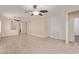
[24,5,48,16]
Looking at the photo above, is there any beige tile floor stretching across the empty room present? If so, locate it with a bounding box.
[0,35,79,54]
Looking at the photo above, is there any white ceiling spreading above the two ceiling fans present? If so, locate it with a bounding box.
[0,5,79,20]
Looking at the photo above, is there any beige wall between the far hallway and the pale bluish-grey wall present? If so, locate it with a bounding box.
[27,15,47,38]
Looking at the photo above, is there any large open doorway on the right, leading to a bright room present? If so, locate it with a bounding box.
[66,10,79,43]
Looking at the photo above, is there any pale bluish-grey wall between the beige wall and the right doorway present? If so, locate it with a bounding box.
[48,15,66,40]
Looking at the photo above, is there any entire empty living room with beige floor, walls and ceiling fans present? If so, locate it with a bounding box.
[0,5,79,54]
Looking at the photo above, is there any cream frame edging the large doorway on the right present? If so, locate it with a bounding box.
[65,8,79,44]
